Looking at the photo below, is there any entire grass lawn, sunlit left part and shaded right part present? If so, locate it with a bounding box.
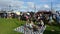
[0,18,60,34]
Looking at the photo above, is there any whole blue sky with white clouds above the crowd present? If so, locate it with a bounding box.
[0,0,60,11]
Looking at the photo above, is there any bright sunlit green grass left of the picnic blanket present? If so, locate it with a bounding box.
[0,18,25,34]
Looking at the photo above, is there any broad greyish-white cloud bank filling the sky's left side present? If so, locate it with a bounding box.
[0,0,24,9]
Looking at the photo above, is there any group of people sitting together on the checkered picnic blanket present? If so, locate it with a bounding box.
[26,20,45,31]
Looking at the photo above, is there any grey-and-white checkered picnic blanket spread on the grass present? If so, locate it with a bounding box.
[14,26,46,34]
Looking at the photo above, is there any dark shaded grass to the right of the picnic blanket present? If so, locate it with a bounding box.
[44,24,60,34]
